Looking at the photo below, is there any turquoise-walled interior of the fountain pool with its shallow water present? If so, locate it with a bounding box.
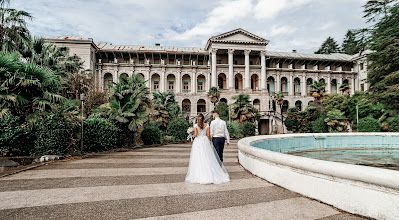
[252,136,399,170]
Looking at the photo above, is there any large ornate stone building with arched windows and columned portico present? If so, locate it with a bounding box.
[47,29,368,134]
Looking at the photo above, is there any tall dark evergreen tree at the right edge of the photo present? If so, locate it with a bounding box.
[368,4,399,110]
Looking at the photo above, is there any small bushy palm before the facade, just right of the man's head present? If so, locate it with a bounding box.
[231,94,260,123]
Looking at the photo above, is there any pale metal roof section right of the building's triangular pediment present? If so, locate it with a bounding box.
[266,51,352,61]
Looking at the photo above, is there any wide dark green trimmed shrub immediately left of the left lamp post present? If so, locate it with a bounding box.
[31,112,80,155]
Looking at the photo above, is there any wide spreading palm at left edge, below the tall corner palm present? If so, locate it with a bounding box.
[0,53,65,125]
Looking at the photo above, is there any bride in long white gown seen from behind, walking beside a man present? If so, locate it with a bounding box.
[186,114,230,184]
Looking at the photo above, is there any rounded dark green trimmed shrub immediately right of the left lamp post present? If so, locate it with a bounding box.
[83,118,118,152]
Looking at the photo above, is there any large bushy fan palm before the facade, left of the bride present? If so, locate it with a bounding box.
[100,74,151,146]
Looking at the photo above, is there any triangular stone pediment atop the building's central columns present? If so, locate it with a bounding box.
[205,28,269,50]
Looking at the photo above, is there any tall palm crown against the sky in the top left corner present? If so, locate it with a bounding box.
[0,0,32,52]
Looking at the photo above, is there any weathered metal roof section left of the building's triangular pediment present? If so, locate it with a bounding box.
[96,43,208,54]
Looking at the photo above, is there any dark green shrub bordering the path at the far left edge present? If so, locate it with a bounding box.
[0,112,34,156]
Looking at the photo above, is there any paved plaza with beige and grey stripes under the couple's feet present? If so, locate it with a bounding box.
[0,142,368,220]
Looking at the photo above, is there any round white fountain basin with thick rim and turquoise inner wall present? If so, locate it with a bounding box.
[238,133,399,219]
